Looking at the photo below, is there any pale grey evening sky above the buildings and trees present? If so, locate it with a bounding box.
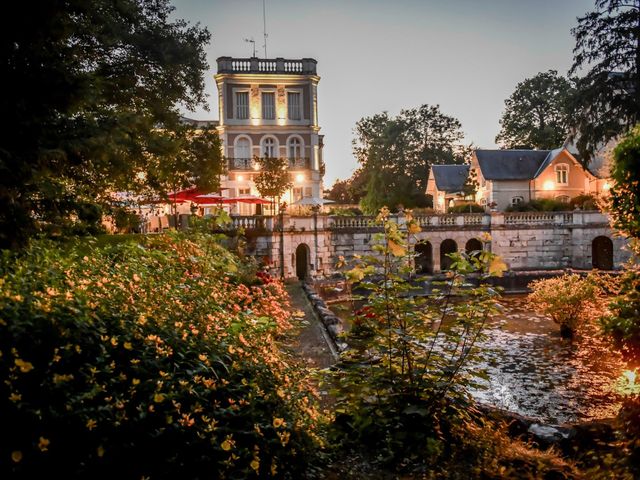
[172,0,594,188]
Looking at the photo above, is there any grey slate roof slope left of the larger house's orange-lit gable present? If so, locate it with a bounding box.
[475,150,555,180]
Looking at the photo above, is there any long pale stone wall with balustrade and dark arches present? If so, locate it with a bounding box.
[222,211,630,278]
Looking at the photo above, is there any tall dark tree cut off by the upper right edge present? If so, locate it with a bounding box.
[569,0,640,160]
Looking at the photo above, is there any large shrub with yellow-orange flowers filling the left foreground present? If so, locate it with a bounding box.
[0,235,321,479]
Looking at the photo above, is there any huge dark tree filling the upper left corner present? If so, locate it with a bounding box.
[0,0,215,247]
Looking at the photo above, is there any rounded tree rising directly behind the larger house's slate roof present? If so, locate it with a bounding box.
[496,70,573,150]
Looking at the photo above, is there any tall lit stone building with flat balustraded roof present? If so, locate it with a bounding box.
[215,57,323,215]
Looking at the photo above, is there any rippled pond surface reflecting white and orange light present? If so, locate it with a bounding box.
[331,295,625,424]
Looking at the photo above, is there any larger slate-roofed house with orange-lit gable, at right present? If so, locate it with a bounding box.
[471,147,607,210]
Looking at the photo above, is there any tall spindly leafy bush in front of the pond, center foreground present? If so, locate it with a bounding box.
[334,209,506,464]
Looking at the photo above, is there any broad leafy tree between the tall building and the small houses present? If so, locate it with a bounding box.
[353,105,471,213]
